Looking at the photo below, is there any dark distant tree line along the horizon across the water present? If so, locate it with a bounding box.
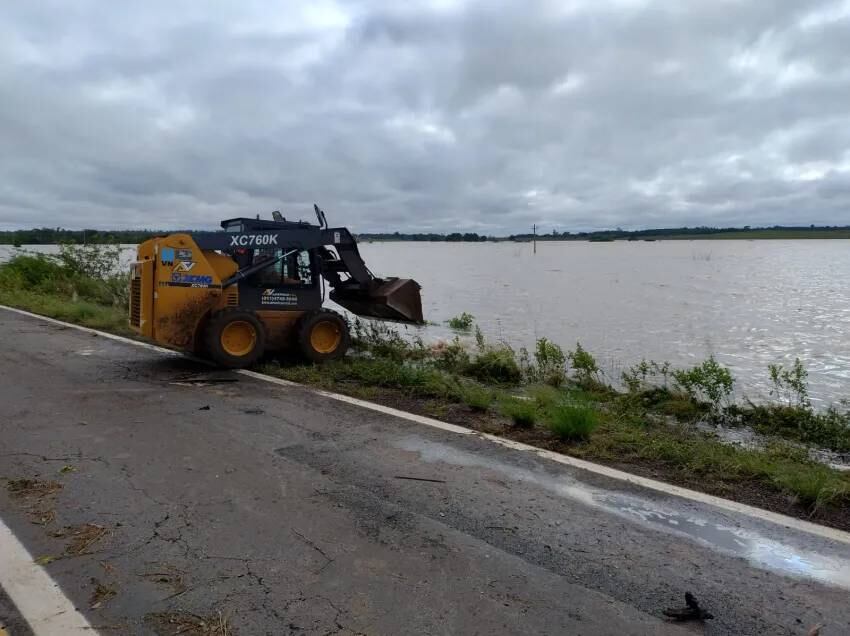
[0,225,850,245]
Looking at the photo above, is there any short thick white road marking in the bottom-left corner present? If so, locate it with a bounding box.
[0,519,97,636]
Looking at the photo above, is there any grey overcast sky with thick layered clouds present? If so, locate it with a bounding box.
[0,0,850,233]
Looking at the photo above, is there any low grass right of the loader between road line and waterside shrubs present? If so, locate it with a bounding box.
[262,358,850,515]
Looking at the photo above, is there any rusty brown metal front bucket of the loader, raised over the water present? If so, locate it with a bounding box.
[330,278,424,324]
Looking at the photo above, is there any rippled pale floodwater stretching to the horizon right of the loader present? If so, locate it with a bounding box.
[0,240,850,406]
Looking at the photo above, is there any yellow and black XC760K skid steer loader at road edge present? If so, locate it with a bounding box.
[130,206,423,368]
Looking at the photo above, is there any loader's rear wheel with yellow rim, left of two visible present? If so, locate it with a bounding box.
[204,309,266,369]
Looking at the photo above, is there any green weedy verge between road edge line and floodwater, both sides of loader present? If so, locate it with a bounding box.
[0,246,850,528]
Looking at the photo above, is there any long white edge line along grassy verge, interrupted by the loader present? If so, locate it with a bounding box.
[0,305,850,544]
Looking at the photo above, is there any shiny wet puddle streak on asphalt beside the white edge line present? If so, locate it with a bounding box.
[397,436,850,589]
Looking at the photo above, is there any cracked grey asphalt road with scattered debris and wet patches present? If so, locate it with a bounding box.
[0,309,850,636]
